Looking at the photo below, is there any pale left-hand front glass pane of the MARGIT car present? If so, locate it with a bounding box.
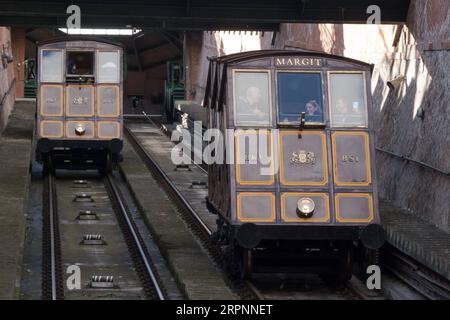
[234,72,271,126]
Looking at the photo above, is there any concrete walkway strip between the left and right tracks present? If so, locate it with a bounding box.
[120,140,237,300]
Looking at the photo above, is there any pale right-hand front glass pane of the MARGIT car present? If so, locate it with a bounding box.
[329,73,367,127]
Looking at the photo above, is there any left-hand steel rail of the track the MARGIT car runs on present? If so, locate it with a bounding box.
[124,126,213,236]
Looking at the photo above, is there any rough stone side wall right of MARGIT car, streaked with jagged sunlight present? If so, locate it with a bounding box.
[372,0,450,231]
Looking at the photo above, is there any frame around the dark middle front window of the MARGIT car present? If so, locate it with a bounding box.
[275,69,327,127]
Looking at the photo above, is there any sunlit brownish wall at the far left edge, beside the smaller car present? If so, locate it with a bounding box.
[0,27,15,133]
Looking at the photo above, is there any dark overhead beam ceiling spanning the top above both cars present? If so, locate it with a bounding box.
[0,0,410,31]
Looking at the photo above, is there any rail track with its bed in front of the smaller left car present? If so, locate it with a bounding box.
[42,170,166,300]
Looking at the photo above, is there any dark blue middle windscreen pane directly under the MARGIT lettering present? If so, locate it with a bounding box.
[277,72,323,124]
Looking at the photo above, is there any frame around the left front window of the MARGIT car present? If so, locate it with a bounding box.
[231,68,273,128]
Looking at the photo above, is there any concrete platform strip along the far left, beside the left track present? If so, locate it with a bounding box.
[0,99,36,300]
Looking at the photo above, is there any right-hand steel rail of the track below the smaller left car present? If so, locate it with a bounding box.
[106,173,165,300]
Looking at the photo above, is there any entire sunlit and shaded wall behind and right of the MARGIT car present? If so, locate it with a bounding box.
[185,0,450,230]
